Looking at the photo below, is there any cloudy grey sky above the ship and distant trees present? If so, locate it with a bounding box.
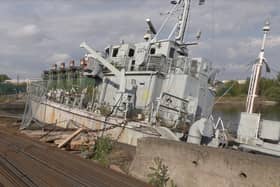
[0,0,280,80]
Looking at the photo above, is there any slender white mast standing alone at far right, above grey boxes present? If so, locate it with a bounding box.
[246,22,270,114]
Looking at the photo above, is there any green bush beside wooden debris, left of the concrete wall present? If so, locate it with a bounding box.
[93,136,113,167]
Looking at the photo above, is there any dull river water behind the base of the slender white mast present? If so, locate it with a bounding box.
[213,104,280,134]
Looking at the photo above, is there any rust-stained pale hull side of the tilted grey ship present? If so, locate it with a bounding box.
[31,100,160,146]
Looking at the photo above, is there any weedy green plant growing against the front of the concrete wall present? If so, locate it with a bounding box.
[148,157,176,187]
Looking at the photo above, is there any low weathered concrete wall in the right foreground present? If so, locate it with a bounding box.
[130,138,280,187]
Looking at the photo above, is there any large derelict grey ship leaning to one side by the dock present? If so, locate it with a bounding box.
[21,0,226,147]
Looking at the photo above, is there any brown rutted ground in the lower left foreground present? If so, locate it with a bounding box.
[0,118,147,187]
